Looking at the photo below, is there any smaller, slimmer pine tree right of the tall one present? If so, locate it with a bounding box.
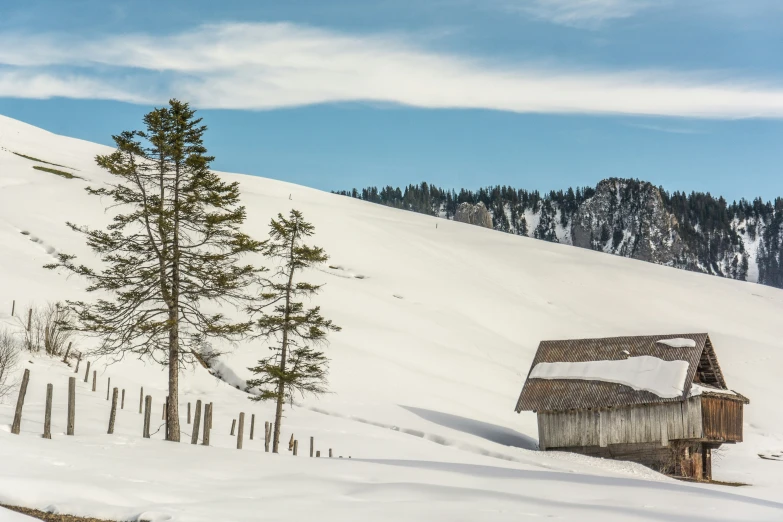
[247,210,340,453]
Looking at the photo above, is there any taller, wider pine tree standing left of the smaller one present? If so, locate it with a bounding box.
[47,100,261,441]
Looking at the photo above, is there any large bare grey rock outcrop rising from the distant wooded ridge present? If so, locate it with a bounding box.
[571,179,684,265]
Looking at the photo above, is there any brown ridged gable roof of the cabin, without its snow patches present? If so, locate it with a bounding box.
[516,333,727,412]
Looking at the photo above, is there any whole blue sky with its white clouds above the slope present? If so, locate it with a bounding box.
[0,0,783,199]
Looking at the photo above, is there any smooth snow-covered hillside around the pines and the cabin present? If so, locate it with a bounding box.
[0,116,783,522]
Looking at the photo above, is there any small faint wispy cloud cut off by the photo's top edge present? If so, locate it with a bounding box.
[504,0,660,27]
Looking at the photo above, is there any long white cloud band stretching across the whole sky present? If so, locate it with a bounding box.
[0,24,783,118]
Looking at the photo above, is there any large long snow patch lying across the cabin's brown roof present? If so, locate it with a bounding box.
[530,355,688,399]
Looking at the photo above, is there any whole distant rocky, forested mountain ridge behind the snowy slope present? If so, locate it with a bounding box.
[342,178,783,288]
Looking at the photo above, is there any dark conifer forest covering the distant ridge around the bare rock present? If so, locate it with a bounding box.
[334,179,783,287]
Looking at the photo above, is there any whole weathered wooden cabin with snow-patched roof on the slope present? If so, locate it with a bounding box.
[516,334,749,480]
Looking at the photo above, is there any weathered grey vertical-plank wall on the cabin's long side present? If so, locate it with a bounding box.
[538,397,704,449]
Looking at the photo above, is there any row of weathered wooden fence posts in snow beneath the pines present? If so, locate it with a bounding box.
[11,355,351,458]
